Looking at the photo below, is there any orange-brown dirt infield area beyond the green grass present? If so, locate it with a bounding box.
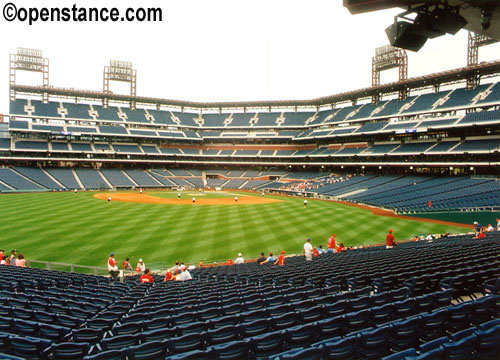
[94,193,282,205]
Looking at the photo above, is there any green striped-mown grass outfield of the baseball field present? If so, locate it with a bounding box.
[0,191,468,266]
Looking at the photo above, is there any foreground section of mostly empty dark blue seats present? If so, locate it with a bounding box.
[0,232,500,360]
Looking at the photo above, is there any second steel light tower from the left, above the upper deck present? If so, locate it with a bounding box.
[103,60,137,109]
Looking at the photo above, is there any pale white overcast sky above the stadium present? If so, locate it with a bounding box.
[0,0,500,113]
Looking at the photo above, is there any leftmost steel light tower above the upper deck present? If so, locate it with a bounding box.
[9,48,49,103]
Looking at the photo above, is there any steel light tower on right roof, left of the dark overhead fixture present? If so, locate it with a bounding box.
[372,45,408,102]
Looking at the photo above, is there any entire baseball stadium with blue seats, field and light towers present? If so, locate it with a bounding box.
[0,1,500,360]
